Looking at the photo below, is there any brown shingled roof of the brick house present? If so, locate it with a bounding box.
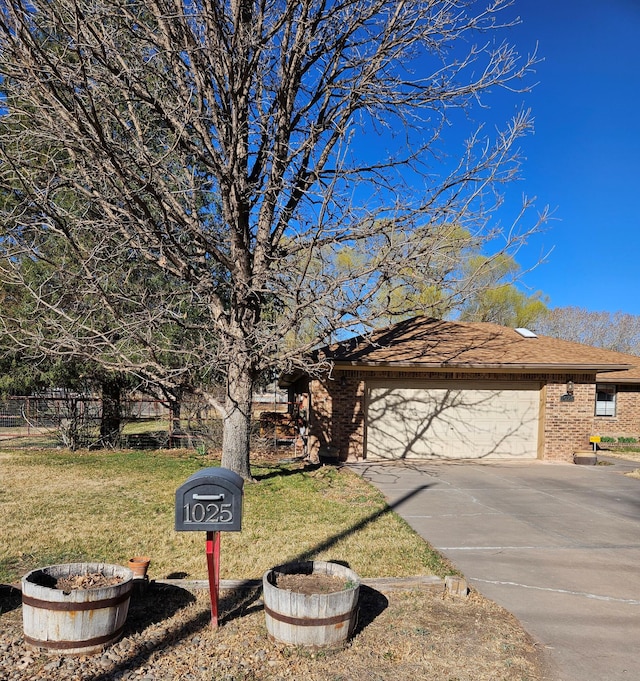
[319,317,640,374]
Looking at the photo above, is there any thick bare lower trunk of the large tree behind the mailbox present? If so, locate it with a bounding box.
[222,361,254,480]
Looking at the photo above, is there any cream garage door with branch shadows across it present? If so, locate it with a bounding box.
[367,381,540,459]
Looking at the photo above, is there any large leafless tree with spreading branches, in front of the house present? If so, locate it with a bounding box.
[0,0,535,477]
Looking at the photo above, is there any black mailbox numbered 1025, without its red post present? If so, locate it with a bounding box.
[176,468,244,532]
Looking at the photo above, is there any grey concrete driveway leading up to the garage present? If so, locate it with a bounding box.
[353,458,640,681]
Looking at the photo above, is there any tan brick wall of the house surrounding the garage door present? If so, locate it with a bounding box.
[309,370,640,462]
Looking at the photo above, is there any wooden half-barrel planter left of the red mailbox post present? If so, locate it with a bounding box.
[22,563,133,655]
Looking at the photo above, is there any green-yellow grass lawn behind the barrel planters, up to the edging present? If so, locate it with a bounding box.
[0,450,451,582]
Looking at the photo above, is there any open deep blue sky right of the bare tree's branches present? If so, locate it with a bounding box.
[491,0,640,314]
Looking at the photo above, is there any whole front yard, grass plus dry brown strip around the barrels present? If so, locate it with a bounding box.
[0,450,547,681]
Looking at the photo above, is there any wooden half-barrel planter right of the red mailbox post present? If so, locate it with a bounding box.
[262,560,360,648]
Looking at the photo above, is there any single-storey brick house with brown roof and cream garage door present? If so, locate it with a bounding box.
[288,317,640,461]
